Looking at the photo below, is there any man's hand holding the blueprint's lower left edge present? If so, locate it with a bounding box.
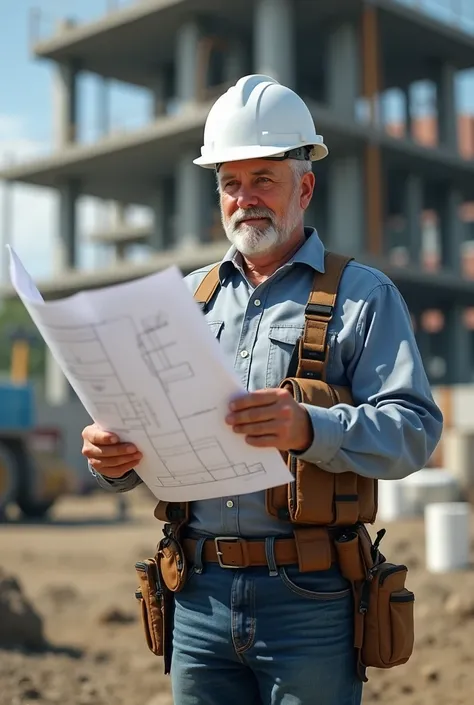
[82,424,142,478]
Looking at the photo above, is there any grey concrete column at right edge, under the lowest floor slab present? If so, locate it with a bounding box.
[443,305,472,384]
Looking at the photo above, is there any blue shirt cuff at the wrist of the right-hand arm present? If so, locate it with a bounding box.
[290,404,343,465]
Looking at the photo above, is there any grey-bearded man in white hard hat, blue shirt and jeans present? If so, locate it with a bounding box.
[83,75,442,705]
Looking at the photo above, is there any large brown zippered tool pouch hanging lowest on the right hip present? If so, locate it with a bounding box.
[356,561,415,668]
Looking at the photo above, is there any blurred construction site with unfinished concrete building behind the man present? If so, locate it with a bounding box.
[0,0,474,705]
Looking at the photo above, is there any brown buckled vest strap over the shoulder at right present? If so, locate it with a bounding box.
[295,252,353,380]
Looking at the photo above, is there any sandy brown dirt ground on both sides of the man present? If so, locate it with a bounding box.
[0,491,474,705]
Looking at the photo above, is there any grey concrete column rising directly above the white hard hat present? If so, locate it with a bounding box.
[253,0,296,89]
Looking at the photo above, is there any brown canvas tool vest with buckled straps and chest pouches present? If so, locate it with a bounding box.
[155,252,377,531]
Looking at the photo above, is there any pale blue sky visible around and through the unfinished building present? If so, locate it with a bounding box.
[0,0,474,279]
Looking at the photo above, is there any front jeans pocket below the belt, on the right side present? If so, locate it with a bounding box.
[278,566,352,601]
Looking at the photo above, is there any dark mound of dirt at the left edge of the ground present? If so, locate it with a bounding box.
[0,568,46,651]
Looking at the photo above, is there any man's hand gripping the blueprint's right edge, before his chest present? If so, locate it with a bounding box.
[226,389,313,451]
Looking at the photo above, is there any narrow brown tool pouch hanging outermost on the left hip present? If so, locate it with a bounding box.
[135,558,173,673]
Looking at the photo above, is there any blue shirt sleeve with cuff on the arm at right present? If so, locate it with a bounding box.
[296,283,443,479]
